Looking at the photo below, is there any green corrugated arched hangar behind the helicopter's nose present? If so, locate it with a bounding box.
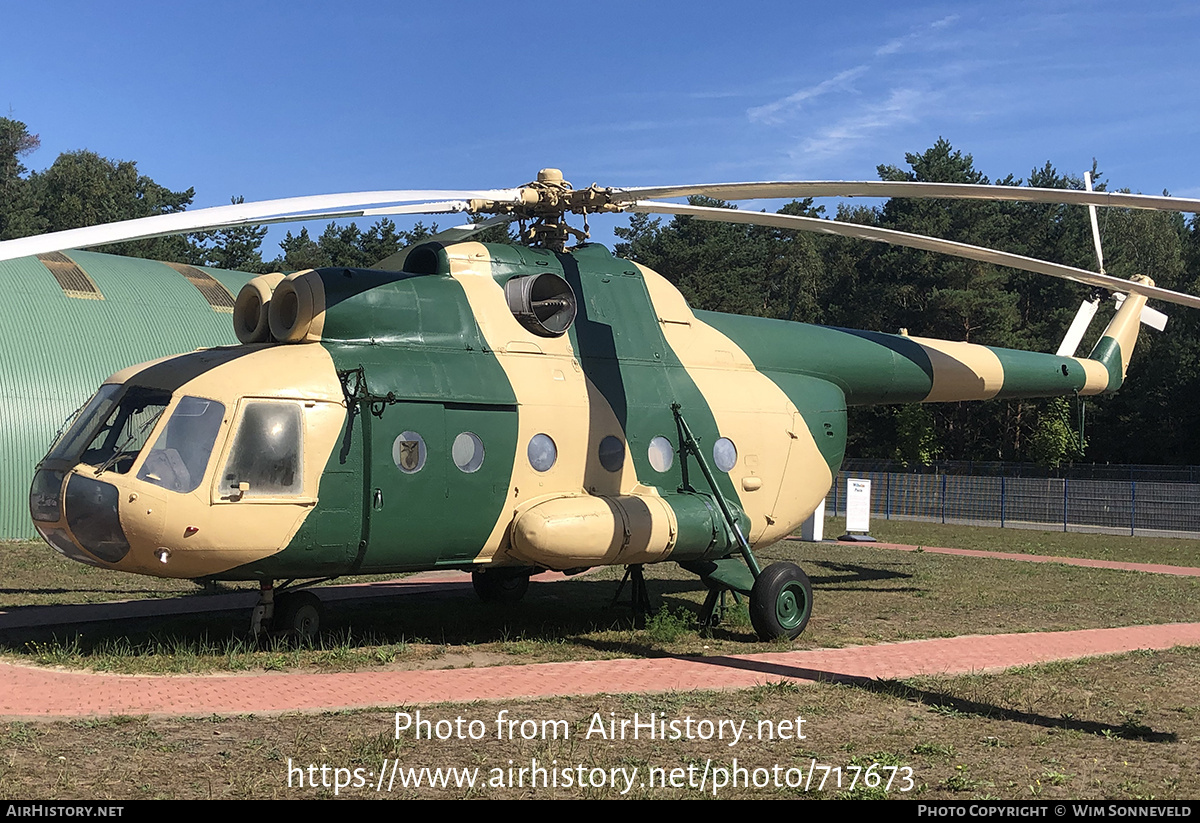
[0,251,254,539]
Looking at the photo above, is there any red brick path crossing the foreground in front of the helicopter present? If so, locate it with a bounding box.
[0,623,1200,717]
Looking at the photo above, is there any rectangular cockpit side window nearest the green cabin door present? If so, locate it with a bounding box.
[221,402,304,497]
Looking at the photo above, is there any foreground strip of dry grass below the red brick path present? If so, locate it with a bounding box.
[0,649,1200,800]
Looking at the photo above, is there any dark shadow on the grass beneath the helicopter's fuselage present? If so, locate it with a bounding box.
[0,561,911,663]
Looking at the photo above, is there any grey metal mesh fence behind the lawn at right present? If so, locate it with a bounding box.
[826,470,1200,537]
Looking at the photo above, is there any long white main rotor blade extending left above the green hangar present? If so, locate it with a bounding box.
[0,188,520,260]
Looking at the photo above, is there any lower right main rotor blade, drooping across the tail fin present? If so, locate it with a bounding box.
[628,200,1200,308]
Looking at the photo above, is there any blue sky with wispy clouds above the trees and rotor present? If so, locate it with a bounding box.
[0,0,1200,257]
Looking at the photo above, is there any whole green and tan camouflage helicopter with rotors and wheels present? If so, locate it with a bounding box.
[9,169,1200,639]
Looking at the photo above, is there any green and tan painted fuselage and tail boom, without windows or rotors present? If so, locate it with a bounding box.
[35,242,1145,579]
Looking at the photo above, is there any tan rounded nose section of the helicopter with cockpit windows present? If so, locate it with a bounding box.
[29,346,347,578]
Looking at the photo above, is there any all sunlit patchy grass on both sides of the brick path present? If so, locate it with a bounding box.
[0,522,1200,800]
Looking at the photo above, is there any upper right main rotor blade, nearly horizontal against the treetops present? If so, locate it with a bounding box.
[613,180,1200,212]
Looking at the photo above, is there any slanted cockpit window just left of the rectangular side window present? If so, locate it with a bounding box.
[138,397,224,492]
